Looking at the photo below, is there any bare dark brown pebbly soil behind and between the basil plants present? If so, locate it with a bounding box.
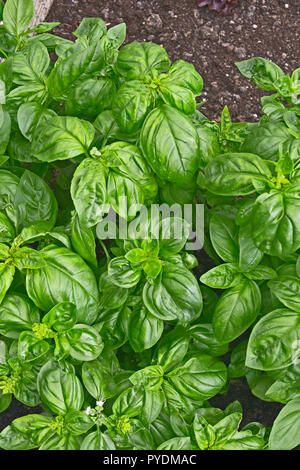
[0,0,300,436]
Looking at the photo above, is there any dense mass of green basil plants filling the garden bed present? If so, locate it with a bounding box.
[0,0,300,450]
